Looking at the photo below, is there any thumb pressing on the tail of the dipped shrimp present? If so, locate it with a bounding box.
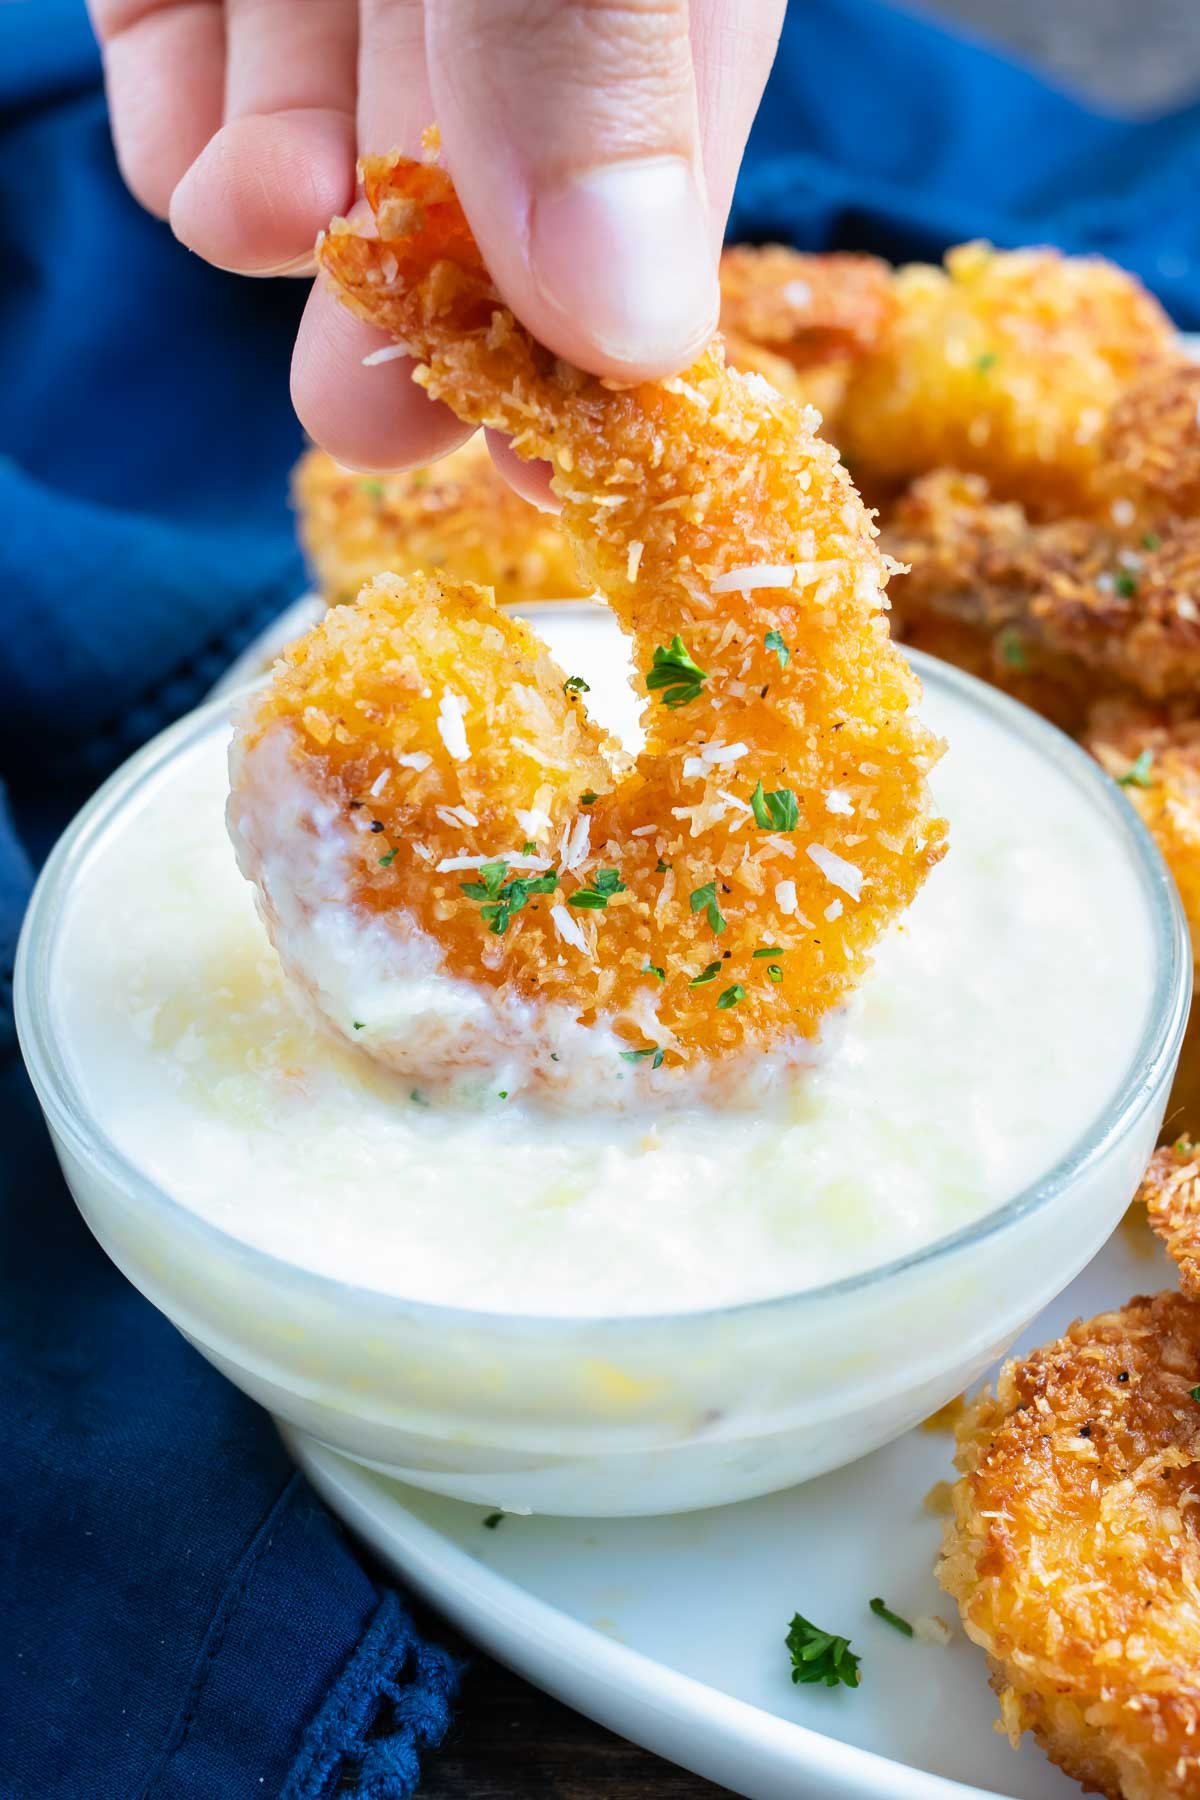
[426,0,720,380]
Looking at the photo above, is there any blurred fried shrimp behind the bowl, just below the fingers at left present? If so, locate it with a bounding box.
[291,437,585,605]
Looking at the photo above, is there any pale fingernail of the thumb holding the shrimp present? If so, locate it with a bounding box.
[529,157,718,369]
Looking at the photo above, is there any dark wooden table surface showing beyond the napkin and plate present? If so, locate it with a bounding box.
[421,0,1200,1800]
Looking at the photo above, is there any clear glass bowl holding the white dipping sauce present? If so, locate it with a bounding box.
[16,655,1191,1516]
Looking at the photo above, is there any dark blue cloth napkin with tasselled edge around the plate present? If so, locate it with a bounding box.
[0,0,1200,1800]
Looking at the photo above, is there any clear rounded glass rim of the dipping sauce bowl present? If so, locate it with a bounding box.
[13,640,1193,1334]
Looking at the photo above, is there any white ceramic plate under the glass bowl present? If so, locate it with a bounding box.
[286,1219,1175,1800]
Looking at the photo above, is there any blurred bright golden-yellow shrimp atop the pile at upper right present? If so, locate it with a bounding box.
[838,243,1177,517]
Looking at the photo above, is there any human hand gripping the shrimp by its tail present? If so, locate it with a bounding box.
[90,0,784,488]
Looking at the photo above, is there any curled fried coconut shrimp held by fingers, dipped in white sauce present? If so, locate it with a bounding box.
[230,147,945,1103]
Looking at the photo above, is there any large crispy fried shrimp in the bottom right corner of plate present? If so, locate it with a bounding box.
[937,1292,1200,1800]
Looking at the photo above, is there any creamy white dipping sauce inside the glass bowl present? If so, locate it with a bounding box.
[52,610,1153,1314]
